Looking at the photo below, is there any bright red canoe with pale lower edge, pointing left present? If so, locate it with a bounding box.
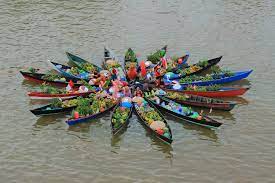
[28,91,94,100]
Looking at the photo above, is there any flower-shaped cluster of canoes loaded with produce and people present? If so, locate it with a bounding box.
[20,46,252,144]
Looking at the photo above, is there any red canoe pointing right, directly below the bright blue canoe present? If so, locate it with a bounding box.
[162,87,250,97]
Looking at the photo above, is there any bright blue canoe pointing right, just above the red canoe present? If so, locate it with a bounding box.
[164,70,253,87]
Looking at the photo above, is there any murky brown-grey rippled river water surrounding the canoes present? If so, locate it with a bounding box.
[0,0,275,182]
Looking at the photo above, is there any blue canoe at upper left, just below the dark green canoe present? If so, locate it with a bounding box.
[50,62,90,80]
